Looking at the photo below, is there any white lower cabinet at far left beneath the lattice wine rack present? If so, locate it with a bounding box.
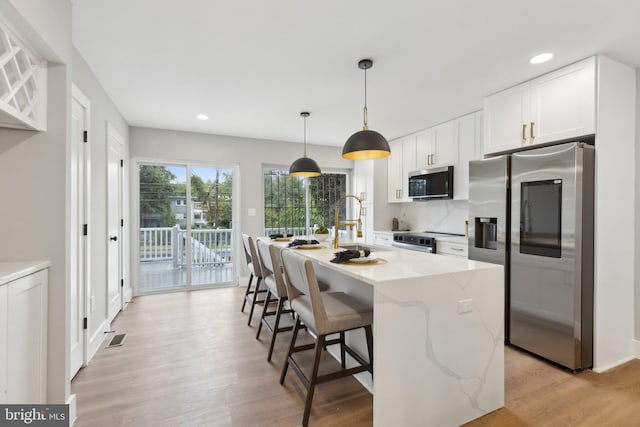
[0,269,48,404]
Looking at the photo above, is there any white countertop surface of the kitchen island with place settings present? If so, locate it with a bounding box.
[265,238,497,286]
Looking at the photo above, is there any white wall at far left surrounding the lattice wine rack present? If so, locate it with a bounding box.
[0,0,71,403]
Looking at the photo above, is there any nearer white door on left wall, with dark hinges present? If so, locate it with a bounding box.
[69,87,89,379]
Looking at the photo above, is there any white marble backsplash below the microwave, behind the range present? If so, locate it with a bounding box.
[398,200,469,234]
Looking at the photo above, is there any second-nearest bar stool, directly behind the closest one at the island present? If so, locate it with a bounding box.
[256,239,293,362]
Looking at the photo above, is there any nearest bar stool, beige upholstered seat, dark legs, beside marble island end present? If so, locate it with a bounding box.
[280,250,373,426]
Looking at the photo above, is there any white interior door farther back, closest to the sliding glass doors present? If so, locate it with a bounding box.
[107,124,124,321]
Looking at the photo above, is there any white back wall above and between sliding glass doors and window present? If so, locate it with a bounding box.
[129,127,352,284]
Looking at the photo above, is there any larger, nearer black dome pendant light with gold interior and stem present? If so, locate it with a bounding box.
[342,59,391,160]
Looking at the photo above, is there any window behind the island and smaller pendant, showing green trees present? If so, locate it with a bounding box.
[264,168,347,236]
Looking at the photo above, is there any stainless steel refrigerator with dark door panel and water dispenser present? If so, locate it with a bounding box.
[469,142,594,370]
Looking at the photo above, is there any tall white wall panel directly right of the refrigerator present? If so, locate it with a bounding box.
[594,57,636,371]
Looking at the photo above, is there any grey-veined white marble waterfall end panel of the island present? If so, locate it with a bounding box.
[374,266,504,427]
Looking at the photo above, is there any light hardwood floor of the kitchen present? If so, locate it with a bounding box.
[72,288,640,427]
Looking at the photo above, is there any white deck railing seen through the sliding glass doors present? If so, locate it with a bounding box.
[140,225,232,268]
